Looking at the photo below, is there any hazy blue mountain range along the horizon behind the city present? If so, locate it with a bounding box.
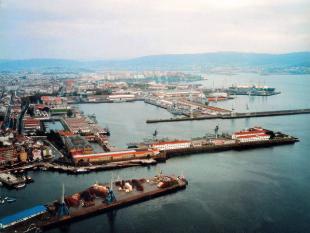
[0,52,310,73]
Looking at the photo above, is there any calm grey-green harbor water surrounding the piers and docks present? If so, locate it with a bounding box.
[0,75,310,233]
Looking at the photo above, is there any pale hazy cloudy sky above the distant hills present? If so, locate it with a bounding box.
[0,0,310,59]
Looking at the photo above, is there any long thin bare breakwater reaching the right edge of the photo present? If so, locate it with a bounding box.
[146,108,310,124]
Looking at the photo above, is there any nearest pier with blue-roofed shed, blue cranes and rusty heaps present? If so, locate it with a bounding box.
[0,174,187,233]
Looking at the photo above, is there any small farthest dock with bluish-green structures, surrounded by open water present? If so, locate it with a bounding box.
[228,85,281,96]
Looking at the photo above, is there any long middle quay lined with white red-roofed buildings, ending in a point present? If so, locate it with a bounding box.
[0,127,299,178]
